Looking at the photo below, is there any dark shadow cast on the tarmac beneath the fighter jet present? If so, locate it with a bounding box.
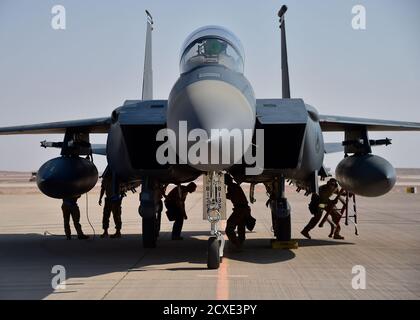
[0,232,351,299]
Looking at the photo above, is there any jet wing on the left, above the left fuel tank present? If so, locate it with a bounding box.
[0,118,111,135]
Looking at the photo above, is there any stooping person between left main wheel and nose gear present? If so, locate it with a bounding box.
[165,182,197,240]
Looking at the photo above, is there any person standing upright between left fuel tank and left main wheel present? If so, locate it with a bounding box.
[99,170,124,238]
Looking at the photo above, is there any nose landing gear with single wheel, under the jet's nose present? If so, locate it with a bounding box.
[205,172,225,269]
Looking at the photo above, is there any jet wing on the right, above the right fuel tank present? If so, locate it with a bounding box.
[319,115,420,132]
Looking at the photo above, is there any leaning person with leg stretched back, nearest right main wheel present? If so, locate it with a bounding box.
[301,178,338,239]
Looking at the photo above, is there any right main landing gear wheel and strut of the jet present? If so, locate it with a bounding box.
[266,177,292,241]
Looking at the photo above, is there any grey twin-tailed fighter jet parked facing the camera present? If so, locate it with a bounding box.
[0,6,420,269]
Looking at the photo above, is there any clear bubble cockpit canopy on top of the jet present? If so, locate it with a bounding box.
[180,26,245,74]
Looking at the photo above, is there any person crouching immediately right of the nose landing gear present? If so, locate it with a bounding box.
[225,174,255,249]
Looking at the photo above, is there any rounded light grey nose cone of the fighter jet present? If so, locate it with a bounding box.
[167,80,255,171]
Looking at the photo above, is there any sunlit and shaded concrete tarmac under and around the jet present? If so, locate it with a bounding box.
[0,170,420,300]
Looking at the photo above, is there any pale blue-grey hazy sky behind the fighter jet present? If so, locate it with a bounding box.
[0,0,420,170]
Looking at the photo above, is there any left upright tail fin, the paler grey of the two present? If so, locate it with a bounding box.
[141,10,153,100]
